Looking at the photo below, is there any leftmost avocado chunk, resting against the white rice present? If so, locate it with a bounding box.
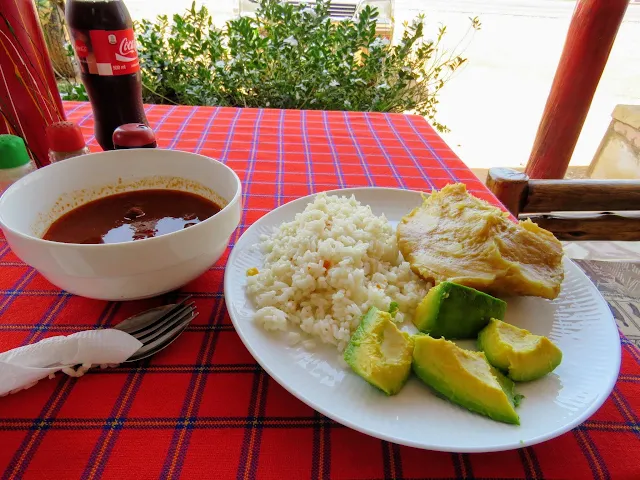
[344,307,413,395]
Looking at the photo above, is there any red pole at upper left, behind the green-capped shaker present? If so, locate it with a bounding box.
[0,0,65,166]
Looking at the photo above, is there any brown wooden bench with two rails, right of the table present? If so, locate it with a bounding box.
[486,168,640,241]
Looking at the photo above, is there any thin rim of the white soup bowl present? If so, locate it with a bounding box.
[0,148,242,250]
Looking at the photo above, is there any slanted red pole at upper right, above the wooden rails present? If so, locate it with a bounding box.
[525,0,629,178]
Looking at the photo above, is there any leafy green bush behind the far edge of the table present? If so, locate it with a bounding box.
[63,0,480,131]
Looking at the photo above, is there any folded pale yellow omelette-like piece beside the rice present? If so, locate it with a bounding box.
[397,184,564,299]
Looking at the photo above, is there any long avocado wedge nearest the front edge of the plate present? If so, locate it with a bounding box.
[413,335,522,425]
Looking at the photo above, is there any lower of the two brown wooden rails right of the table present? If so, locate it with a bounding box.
[520,213,640,241]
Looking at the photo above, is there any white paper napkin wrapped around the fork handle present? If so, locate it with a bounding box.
[0,328,142,396]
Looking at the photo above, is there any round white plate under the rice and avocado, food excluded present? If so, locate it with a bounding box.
[224,188,620,452]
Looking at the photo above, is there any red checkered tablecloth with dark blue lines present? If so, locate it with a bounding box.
[0,103,640,480]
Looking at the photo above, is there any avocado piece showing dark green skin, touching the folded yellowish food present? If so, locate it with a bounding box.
[413,282,507,338]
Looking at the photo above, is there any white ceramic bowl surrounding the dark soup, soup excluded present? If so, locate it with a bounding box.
[0,149,242,300]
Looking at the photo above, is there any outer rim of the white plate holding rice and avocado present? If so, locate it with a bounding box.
[223,187,622,453]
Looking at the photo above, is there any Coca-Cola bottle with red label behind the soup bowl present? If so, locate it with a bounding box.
[66,0,148,150]
